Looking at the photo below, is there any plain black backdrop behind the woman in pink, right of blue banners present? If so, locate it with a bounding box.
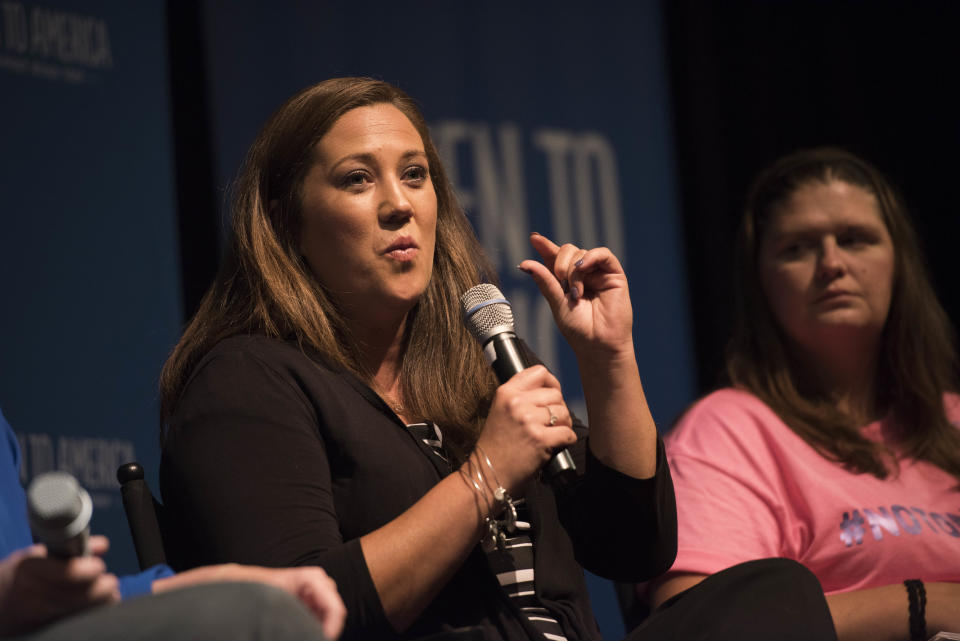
[664,0,960,391]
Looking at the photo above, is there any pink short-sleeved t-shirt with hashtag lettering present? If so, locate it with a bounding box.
[666,389,960,594]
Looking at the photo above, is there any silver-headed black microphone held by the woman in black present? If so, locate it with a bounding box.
[460,283,577,483]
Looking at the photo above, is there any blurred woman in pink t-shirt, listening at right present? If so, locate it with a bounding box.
[652,148,960,641]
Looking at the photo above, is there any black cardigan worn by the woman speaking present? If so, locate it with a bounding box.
[160,335,676,641]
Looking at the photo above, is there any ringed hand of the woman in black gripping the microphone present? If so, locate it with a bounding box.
[477,365,577,496]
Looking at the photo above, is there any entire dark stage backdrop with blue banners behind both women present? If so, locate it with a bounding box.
[0,0,960,639]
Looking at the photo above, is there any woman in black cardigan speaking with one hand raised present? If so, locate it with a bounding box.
[160,78,832,641]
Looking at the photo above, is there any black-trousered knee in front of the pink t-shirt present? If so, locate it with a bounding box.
[627,559,837,641]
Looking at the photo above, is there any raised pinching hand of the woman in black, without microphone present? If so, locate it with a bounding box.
[519,233,633,357]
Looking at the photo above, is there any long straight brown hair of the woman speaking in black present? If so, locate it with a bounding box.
[160,78,496,448]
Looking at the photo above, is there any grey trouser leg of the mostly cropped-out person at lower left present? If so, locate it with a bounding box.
[12,583,325,641]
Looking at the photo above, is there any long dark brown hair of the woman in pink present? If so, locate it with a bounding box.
[727,147,960,479]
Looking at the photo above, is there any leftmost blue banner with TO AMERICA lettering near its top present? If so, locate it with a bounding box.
[0,0,181,572]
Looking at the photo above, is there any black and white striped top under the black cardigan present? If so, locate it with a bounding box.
[407,423,567,641]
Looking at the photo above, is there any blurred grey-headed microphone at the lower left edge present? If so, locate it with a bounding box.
[27,472,93,559]
